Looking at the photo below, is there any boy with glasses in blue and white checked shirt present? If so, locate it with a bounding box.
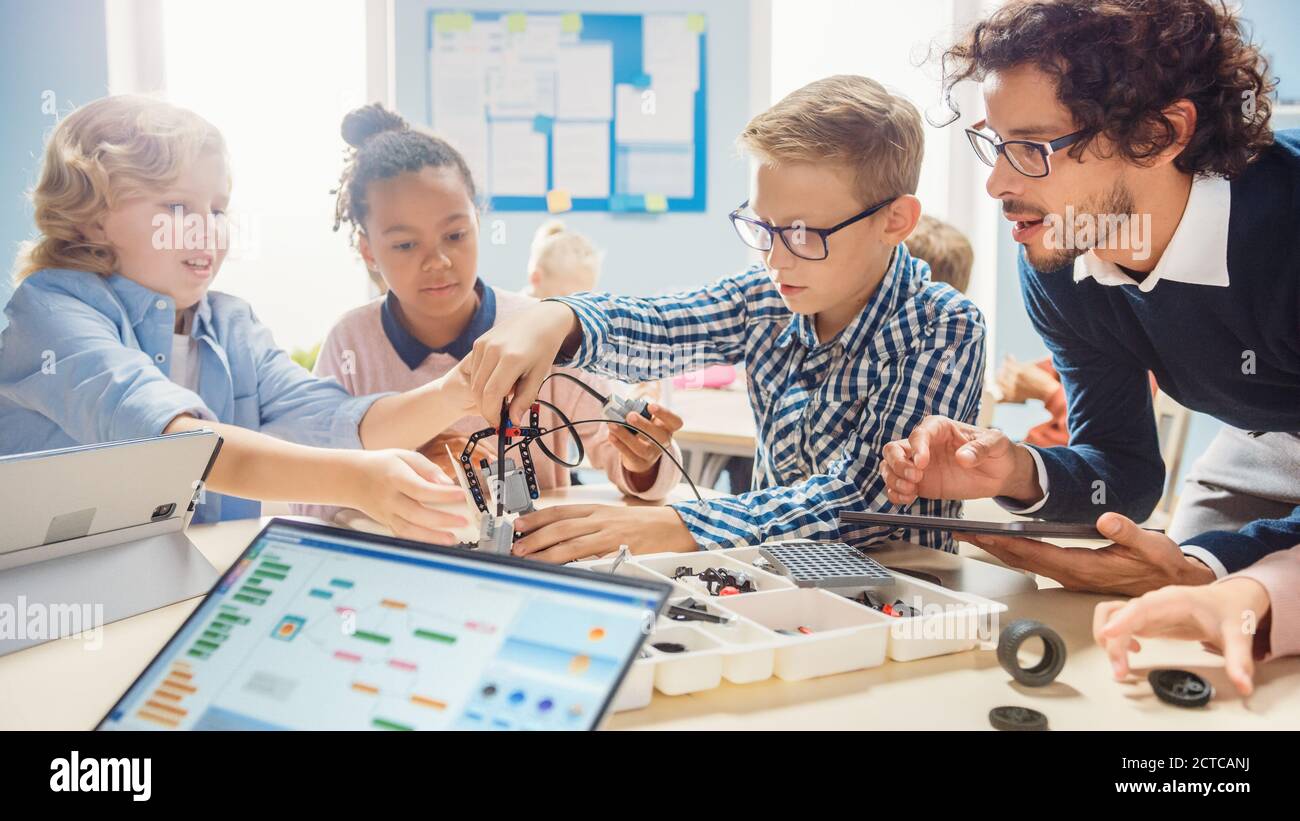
[460,75,984,561]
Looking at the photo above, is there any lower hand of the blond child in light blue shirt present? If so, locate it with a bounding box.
[350,449,469,544]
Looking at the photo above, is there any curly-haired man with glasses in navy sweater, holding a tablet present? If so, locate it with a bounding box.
[885,0,1300,595]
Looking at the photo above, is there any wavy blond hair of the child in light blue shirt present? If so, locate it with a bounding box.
[13,95,226,282]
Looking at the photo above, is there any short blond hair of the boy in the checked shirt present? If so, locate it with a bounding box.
[737,74,926,205]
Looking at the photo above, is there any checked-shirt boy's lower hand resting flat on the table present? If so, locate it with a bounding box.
[514,504,699,564]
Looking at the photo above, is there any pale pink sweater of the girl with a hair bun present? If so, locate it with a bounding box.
[293,288,681,521]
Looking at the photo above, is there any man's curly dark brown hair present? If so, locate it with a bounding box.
[941,0,1277,179]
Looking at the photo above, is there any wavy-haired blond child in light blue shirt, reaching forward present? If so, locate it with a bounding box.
[0,96,468,543]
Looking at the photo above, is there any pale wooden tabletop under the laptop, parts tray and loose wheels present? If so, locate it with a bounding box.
[0,486,1300,730]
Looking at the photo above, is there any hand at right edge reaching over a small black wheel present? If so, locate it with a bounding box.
[1092,578,1271,695]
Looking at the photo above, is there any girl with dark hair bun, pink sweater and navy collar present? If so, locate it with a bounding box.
[296,104,681,520]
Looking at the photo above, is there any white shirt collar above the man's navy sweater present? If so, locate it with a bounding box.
[1074,177,1232,294]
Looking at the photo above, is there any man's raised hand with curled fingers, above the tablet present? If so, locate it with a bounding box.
[881,416,1043,504]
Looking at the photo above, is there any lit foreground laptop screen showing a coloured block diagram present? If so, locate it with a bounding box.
[100,520,668,730]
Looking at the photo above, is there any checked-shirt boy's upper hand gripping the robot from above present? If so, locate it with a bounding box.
[469,303,581,422]
